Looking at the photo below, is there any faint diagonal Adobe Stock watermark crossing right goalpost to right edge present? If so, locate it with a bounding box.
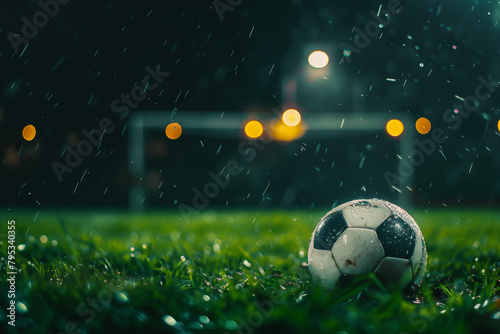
[384,74,500,192]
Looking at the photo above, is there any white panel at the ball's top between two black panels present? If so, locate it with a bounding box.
[342,200,391,229]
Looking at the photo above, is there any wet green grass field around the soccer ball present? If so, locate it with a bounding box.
[0,208,500,334]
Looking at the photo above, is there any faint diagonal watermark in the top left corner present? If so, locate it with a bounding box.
[7,0,71,53]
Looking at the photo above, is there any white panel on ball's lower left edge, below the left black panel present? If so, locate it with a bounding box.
[307,247,342,289]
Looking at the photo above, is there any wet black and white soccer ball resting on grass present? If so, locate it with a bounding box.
[307,199,427,289]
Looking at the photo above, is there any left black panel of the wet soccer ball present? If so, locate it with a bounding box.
[313,211,347,251]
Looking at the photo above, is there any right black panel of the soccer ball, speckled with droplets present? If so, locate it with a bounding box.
[376,215,417,260]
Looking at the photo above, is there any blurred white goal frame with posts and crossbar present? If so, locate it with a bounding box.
[128,111,416,210]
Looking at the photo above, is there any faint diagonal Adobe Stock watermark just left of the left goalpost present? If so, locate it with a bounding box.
[51,65,170,182]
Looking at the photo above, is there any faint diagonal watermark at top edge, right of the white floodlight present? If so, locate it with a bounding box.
[339,0,404,63]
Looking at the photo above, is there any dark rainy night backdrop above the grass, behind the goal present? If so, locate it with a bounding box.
[0,0,500,208]
